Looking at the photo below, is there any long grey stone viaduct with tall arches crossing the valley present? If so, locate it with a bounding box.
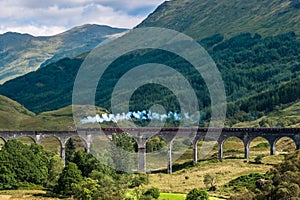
[0,128,300,173]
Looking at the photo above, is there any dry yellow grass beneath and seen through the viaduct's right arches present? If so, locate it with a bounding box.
[147,137,295,198]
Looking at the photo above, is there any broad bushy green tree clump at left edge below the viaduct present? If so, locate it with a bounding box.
[0,140,49,189]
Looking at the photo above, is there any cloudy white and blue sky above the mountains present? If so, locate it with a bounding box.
[0,0,164,36]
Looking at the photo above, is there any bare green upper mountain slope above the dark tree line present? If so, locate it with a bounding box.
[137,0,300,39]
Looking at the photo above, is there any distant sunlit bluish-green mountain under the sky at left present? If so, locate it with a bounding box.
[0,25,126,84]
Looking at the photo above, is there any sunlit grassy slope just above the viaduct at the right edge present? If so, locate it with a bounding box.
[233,101,300,128]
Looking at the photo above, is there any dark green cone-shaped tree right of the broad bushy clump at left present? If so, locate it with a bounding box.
[55,162,83,195]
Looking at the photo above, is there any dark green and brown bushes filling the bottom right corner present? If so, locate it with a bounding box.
[228,150,300,200]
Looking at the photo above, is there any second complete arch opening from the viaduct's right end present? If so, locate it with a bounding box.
[247,135,271,156]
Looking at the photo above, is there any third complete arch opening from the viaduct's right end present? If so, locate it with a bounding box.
[221,135,245,158]
